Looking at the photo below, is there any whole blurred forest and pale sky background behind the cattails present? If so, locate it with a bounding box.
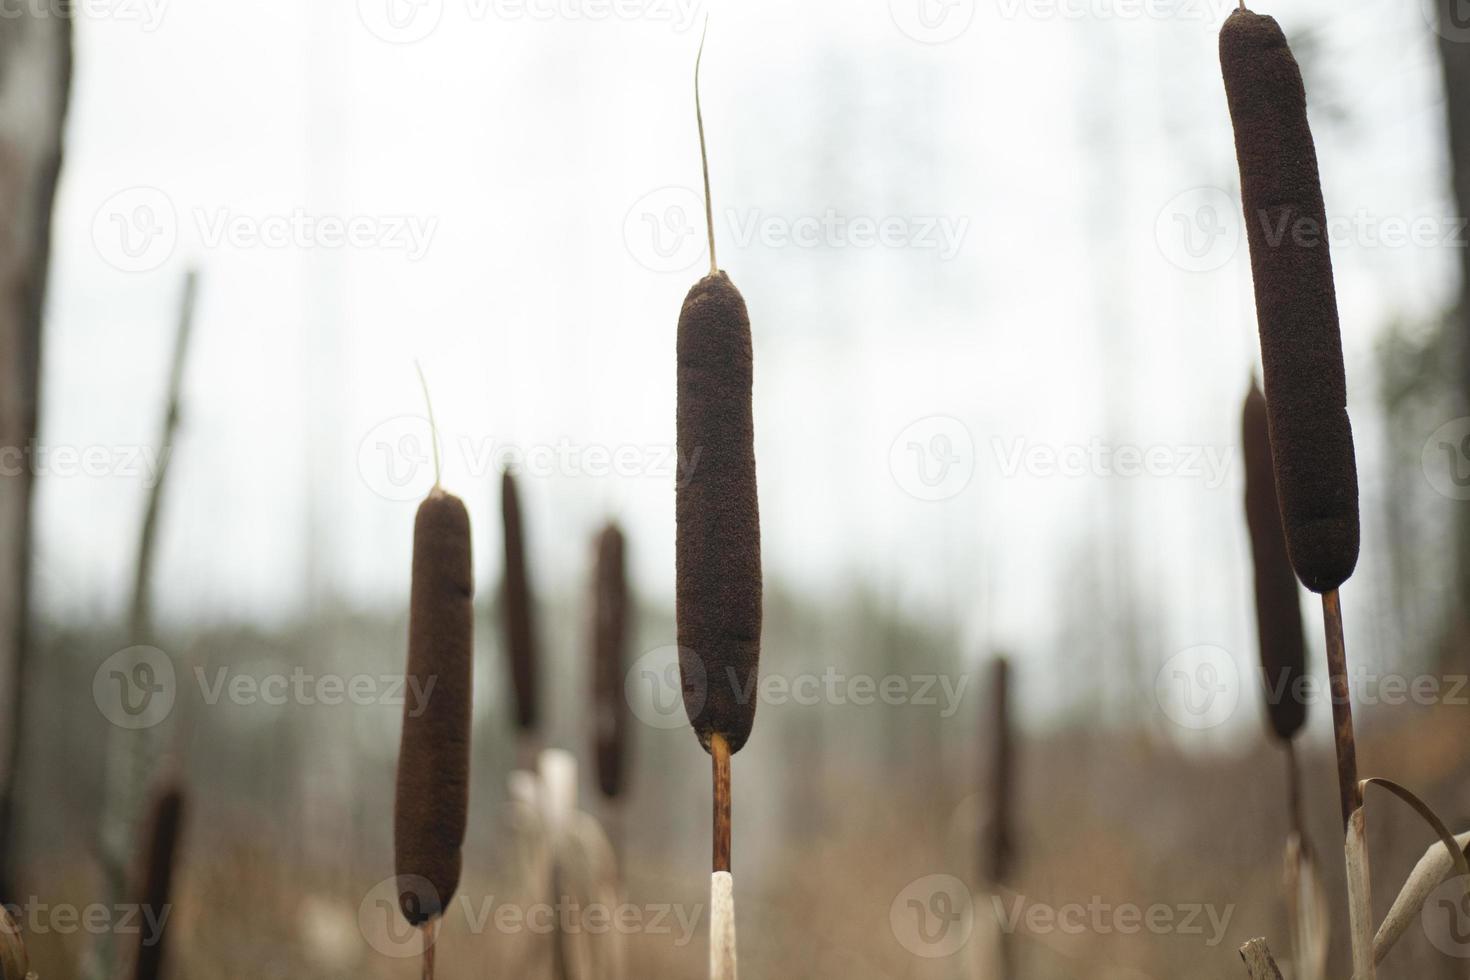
[0,0,1470,980]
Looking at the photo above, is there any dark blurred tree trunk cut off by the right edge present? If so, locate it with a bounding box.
[1439,0,1470,649]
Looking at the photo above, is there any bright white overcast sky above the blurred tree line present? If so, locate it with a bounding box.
[28,0,1455,734]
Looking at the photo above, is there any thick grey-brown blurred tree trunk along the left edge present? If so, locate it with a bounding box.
[0,4,72,901]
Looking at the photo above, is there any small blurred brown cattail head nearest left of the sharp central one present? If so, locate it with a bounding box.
[592,525,628,798]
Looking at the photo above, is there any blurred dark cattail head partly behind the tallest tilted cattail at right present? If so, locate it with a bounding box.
[1241,382,1307,741]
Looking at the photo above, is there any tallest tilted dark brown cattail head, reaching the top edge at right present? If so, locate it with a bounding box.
[1220,10,1358,592]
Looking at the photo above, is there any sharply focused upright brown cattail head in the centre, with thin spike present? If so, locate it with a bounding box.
[675,272,761,752]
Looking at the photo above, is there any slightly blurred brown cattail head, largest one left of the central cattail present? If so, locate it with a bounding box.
[392,488,475,926]
